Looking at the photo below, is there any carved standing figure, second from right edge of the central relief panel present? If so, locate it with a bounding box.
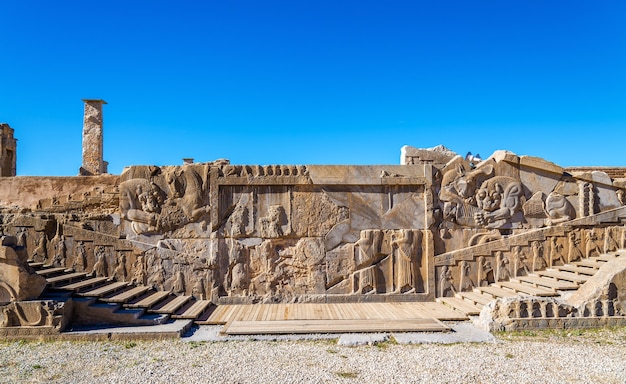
[391,229,417,293]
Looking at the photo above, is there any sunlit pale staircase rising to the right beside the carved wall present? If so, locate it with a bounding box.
[437,250,626,316]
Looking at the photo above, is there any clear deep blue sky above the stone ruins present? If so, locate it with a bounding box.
[0,0,626,175]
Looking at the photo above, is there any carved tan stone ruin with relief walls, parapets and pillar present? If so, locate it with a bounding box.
[0,100,626,335]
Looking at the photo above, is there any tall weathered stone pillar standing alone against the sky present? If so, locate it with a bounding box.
[80,99,108,176]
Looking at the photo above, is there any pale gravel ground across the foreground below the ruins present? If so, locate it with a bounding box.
[0,328,626,383]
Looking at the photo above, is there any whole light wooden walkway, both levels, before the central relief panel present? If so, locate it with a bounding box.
[201,302,467,334]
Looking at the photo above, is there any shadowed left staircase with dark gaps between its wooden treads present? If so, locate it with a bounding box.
[29,262,215,325]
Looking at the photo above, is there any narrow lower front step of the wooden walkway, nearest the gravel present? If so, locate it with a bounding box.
[223,319,450,335]
